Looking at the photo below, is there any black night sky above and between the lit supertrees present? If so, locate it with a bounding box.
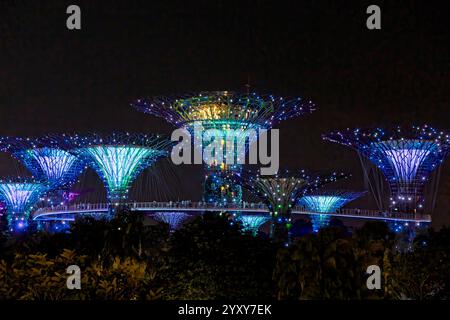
[0,0,450,226]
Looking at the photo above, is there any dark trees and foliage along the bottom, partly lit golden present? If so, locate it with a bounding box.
[0,212,450,300]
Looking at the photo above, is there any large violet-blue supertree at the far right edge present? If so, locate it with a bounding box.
[323,125,450,213]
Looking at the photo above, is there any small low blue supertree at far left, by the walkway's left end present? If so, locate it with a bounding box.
[0,178,48,231]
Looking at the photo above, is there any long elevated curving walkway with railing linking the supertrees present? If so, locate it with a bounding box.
[33,201,431,222]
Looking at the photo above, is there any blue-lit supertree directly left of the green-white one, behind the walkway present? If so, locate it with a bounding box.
[1,137,85,204]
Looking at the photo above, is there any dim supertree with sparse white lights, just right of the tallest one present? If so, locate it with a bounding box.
[235,170,350,244]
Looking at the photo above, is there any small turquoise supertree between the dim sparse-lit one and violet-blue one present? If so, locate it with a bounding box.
[299,190,366,232]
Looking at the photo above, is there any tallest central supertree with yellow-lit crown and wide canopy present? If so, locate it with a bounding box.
[132,91,314,205]
